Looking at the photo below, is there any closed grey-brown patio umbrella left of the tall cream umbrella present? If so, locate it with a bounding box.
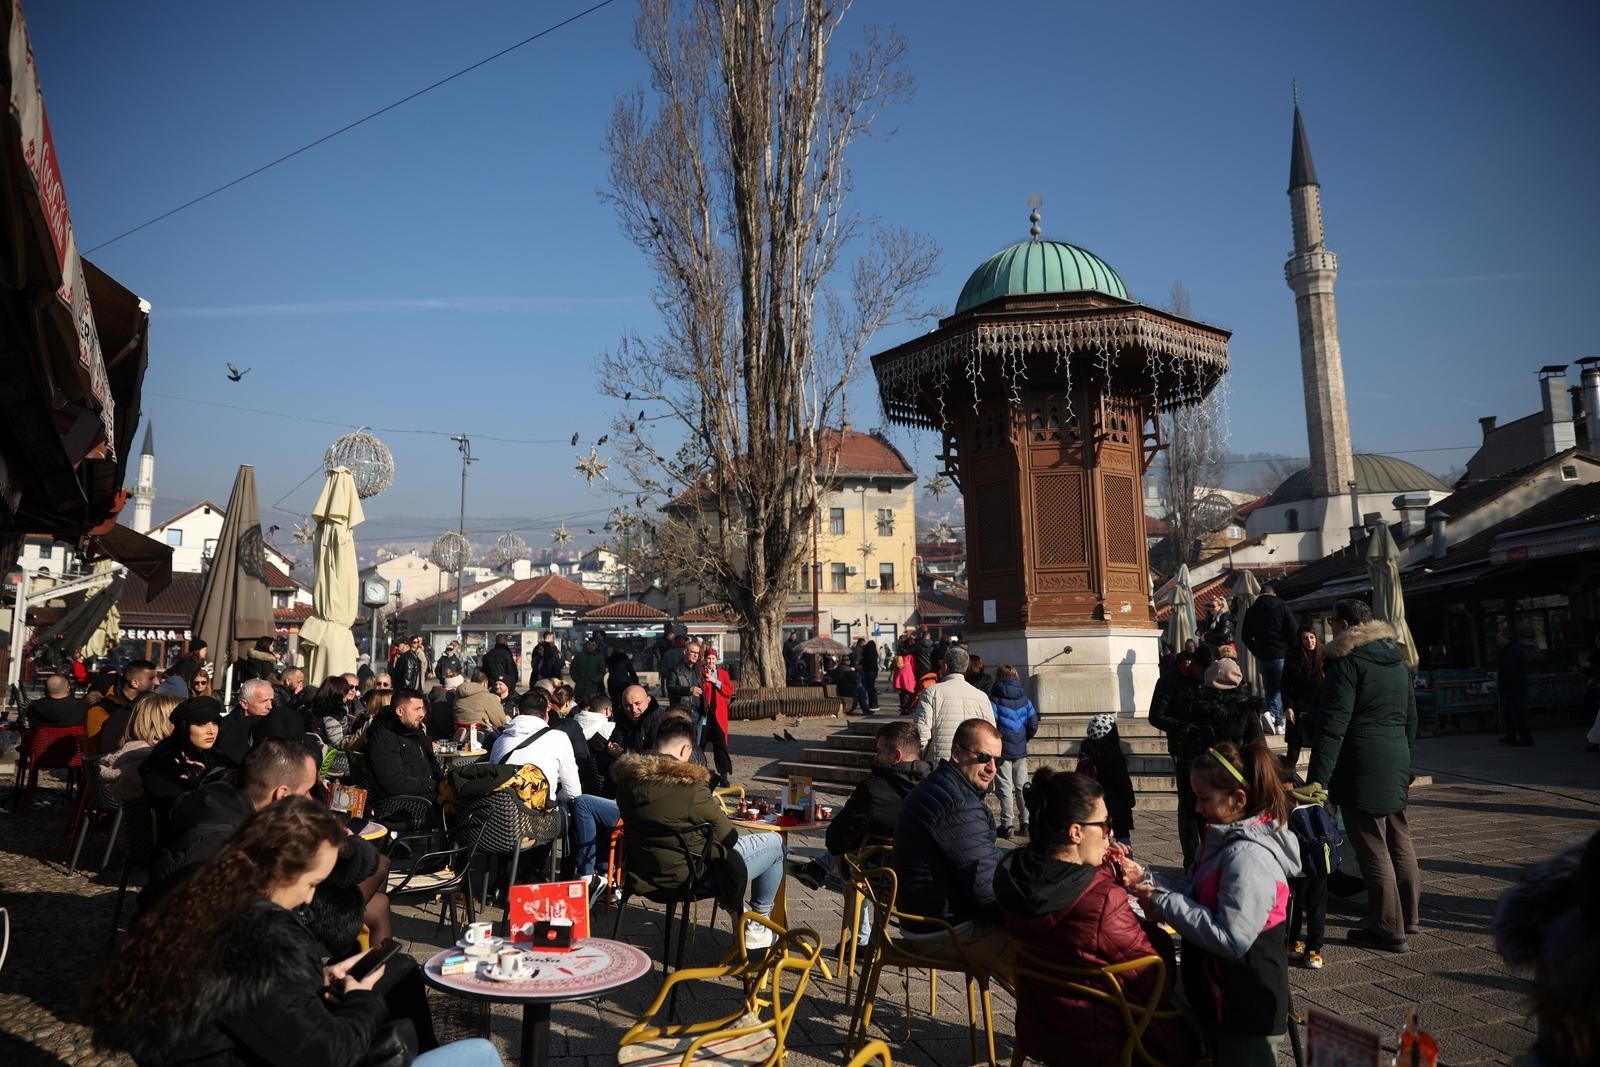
[194,464,277,697]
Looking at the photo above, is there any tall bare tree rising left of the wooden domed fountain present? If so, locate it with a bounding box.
[598,0,938,685]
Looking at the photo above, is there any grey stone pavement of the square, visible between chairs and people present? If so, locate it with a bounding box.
[0,720,1600,1067]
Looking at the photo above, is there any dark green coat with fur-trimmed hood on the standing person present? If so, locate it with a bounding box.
[1306,621,1416,816]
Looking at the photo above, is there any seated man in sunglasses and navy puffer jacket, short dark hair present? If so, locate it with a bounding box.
[893,718,1016,985]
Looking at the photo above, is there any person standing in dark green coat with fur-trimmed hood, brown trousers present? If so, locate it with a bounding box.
[1306,600,1422,952]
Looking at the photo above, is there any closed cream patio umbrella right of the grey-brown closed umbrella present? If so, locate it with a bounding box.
[301,467,366,685]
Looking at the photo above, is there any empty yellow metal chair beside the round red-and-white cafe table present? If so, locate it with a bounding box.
[616,912,822,1067]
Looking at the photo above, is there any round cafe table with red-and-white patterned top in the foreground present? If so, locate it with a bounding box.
[422,937,651,1067]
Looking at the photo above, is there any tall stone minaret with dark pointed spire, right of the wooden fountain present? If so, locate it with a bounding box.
[1283,90,1355,498]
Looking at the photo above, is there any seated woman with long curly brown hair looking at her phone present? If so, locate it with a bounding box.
[83,797,501,1067]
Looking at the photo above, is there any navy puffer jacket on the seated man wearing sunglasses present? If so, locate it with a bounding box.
[893,760,1002,933]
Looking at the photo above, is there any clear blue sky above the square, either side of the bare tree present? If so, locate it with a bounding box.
[27,0,1600,545]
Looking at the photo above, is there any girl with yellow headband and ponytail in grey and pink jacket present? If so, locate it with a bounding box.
[1136,741,1299,1067]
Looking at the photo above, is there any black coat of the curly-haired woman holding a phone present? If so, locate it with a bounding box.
[94,899,389,1067]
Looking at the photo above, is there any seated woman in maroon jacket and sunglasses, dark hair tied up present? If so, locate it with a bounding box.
[995,768,1200,1067]
